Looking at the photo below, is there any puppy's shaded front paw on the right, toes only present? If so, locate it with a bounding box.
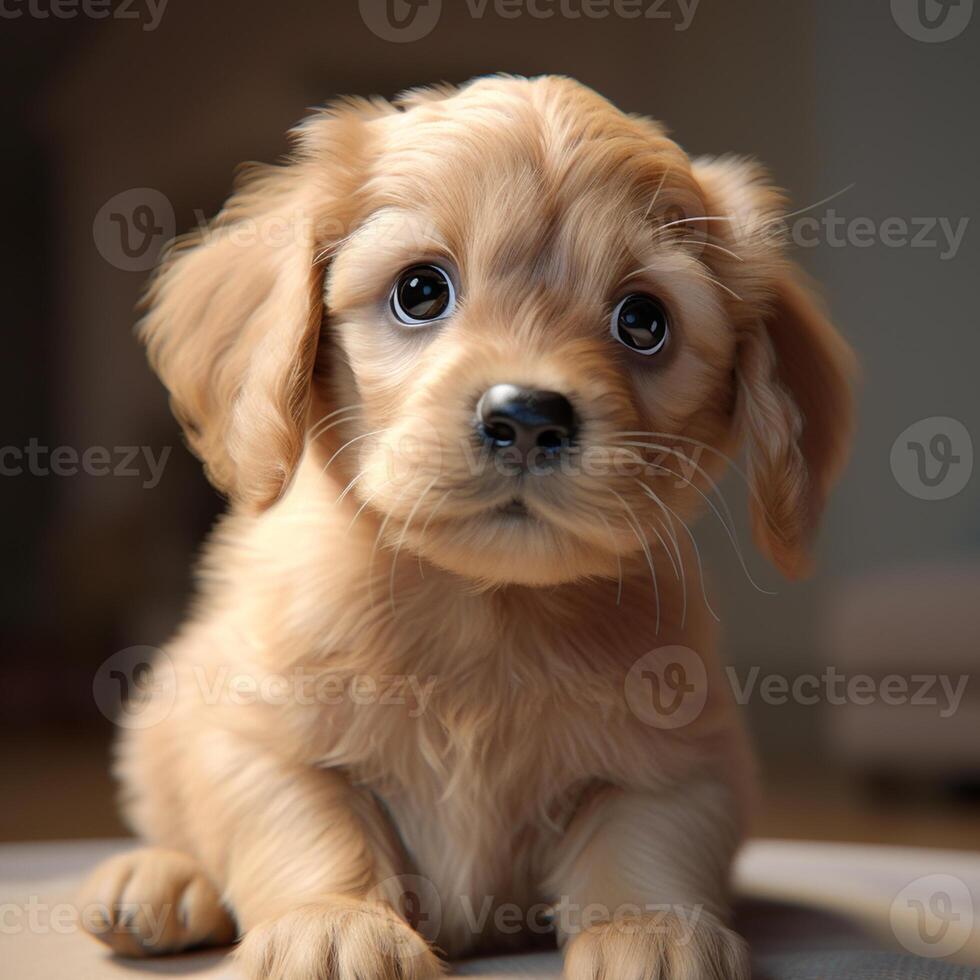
[564,909,750,980]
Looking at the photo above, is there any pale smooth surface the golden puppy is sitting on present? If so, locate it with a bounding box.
[0,841,980,980]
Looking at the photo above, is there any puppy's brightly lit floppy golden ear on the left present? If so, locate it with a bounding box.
[139,101,393,511]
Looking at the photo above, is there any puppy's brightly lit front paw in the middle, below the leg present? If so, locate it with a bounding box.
[237,896,442,980]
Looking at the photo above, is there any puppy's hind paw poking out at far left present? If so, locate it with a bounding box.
[77,847,235,956]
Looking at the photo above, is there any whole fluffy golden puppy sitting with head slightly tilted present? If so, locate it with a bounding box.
[82,77,851,980]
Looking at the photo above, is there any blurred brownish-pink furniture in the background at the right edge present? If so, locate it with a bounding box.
[824,562,980,788]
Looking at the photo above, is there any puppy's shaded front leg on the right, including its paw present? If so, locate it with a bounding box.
[547,783,749,980]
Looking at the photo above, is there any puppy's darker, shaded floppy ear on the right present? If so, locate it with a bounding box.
[695,159,855,578]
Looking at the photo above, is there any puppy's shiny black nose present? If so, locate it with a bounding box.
[476,385,577,457]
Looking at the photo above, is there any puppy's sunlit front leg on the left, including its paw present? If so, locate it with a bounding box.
[191,735,441,980]
